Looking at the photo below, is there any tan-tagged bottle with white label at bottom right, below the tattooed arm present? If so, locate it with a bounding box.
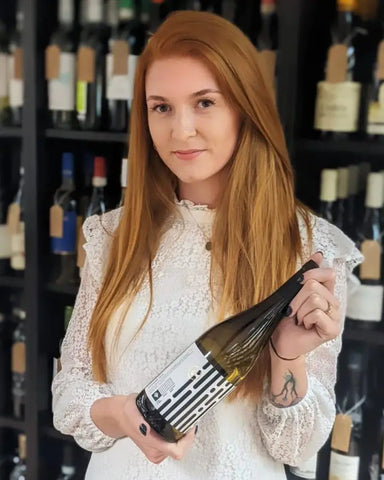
[329,351,365,480]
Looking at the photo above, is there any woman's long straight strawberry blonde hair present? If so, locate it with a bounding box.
[88,11,310,400]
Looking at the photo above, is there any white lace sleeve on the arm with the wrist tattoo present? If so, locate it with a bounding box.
[257,217,362,465]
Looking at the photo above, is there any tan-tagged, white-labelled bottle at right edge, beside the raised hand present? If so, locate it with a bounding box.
[347,172,383,328]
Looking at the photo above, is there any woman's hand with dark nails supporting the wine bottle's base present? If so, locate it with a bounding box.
[120,393,195,464]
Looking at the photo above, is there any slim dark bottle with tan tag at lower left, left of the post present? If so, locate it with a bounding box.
[12,305,26,419]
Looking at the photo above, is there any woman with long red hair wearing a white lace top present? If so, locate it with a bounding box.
[53,12,361,480]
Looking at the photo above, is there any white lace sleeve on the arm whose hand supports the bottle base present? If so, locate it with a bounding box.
[52,217,116,452]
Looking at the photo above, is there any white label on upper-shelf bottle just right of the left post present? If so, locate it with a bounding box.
[48,53,76,111]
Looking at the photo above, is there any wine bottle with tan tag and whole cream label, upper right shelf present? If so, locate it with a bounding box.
[315,0,361,138]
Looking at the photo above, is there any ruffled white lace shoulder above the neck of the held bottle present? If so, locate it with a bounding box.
[297,212,363,271]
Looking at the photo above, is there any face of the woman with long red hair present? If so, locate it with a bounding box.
[145,57,240,202]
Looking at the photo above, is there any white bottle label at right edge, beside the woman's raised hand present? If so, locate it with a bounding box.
[347,285,384,322]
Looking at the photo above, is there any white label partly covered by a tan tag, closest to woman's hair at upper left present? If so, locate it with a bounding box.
[107,53,138,100]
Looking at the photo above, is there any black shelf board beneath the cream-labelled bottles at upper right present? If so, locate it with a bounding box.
[295,139,384,157]
